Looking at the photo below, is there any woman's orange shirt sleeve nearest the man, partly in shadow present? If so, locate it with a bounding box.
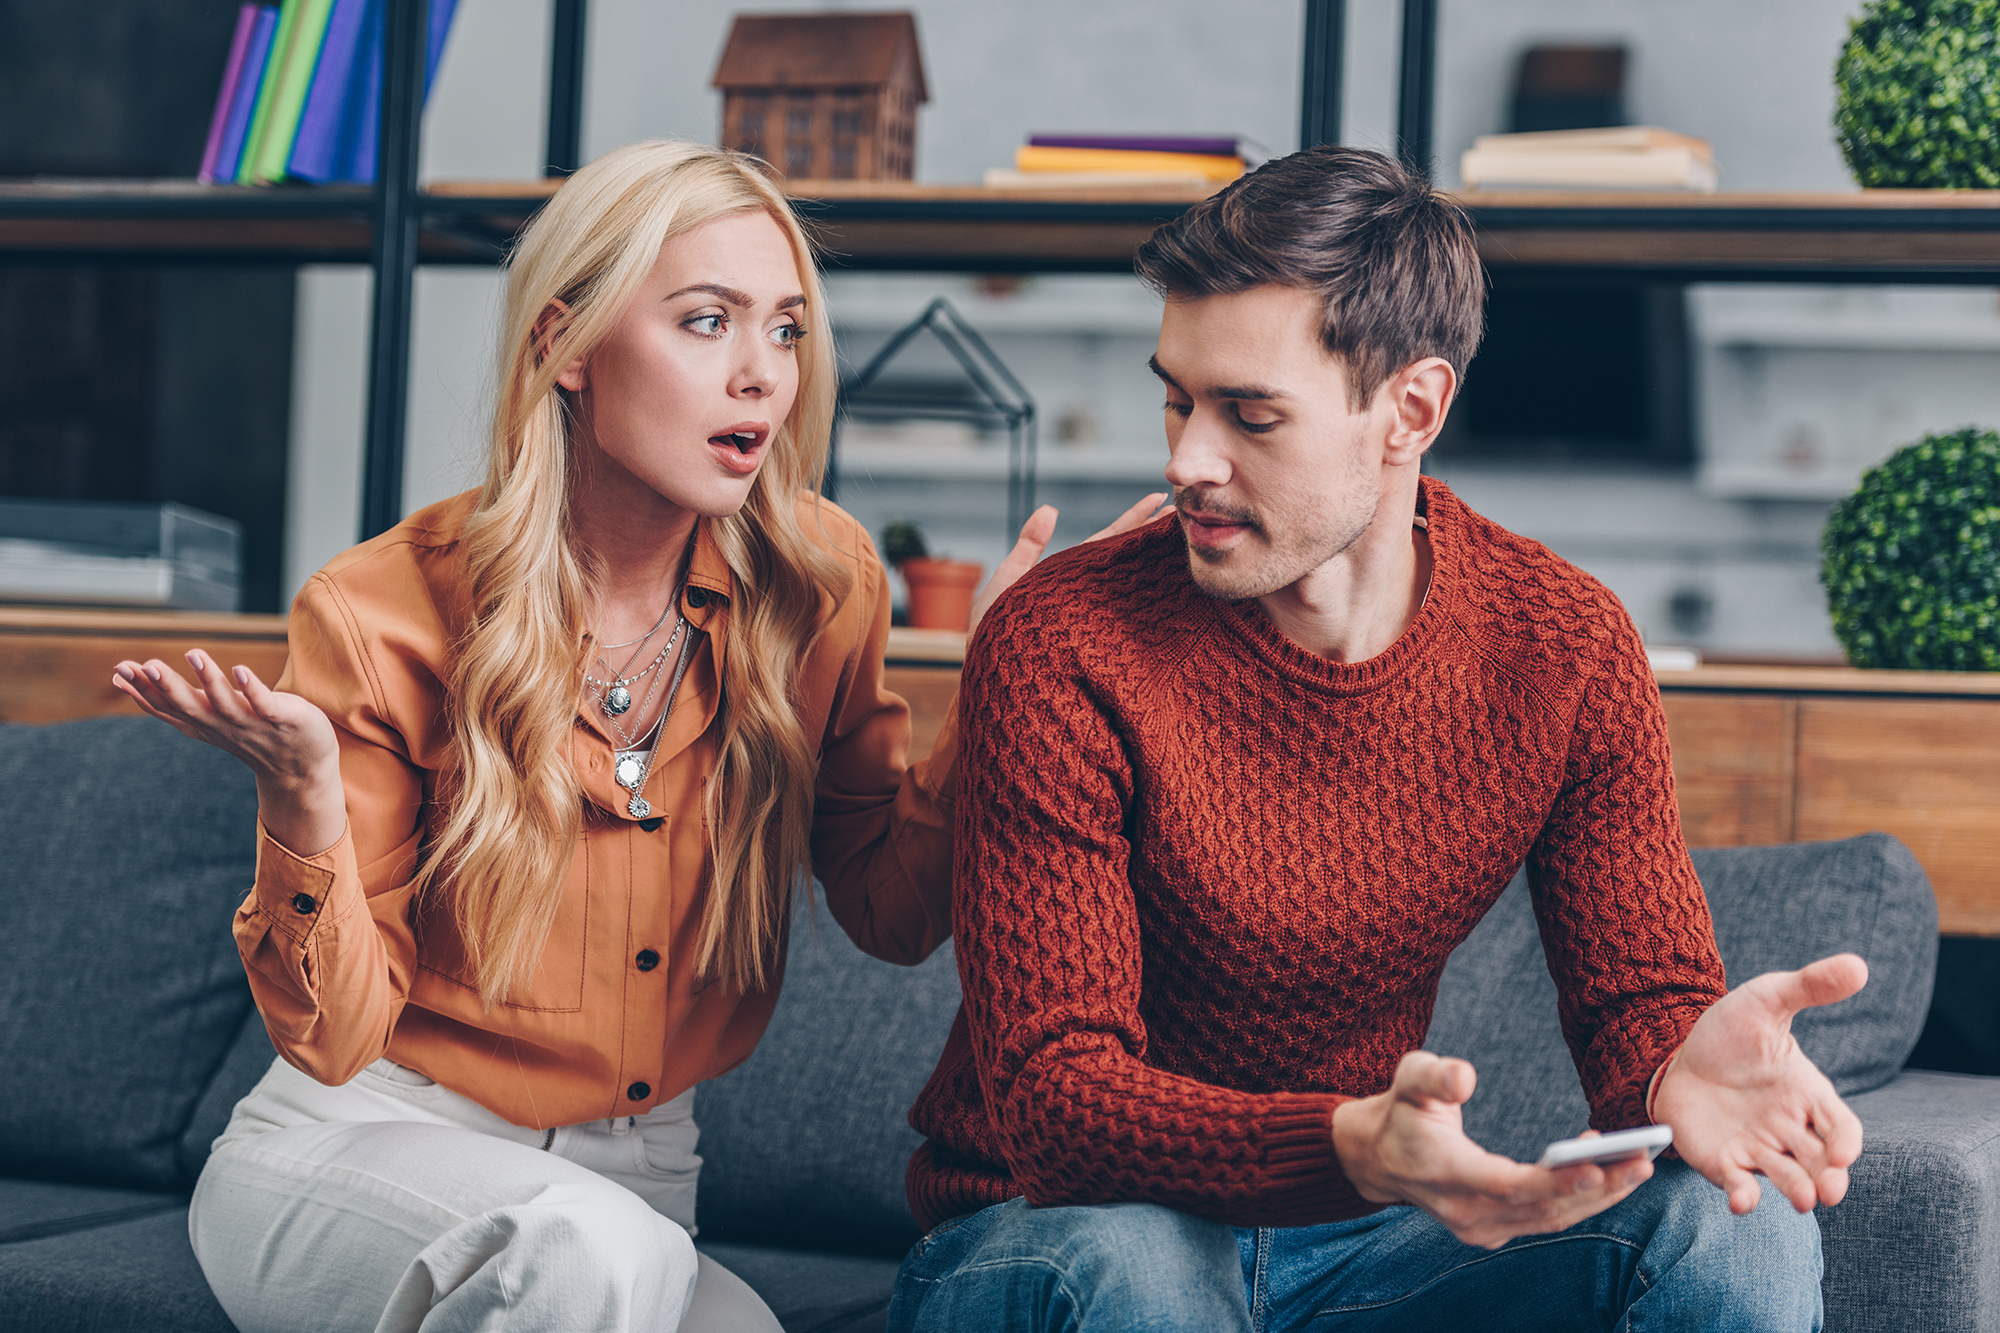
[812,532,958,965]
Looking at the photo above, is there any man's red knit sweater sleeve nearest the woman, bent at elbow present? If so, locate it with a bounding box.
[954,598,1374,1225]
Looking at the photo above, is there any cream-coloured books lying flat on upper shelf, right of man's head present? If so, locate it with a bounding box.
[1458,126,1716,194]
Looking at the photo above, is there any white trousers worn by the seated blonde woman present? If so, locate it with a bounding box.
[188,1061,780,1333]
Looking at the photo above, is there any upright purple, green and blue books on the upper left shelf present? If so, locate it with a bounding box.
[198,0,458,184]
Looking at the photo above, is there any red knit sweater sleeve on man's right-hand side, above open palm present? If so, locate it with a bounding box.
[1528,612,1728,1131]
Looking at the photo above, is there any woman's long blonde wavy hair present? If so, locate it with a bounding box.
[418,140,852,1005]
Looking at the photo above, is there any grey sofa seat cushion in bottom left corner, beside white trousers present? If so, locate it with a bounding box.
[0,1207,236,1333]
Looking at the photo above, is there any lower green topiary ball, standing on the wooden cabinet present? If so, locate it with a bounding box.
[1820,426,2000,671]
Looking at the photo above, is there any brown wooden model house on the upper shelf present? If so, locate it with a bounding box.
[714,12,930,180]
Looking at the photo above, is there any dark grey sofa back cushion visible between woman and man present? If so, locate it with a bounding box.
[694,903,958,1255]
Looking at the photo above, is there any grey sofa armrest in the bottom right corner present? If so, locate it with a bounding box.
[1818,1071,2000,1333]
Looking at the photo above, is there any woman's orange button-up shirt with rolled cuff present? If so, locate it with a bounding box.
[234,492,956,1129]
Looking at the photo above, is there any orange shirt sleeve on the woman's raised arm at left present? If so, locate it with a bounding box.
[234,574,424,1087]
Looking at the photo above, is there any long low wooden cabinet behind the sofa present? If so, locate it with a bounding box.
[0,606,2000,937]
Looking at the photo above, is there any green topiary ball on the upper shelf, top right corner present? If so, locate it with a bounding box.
[1834,0,2000,190]
